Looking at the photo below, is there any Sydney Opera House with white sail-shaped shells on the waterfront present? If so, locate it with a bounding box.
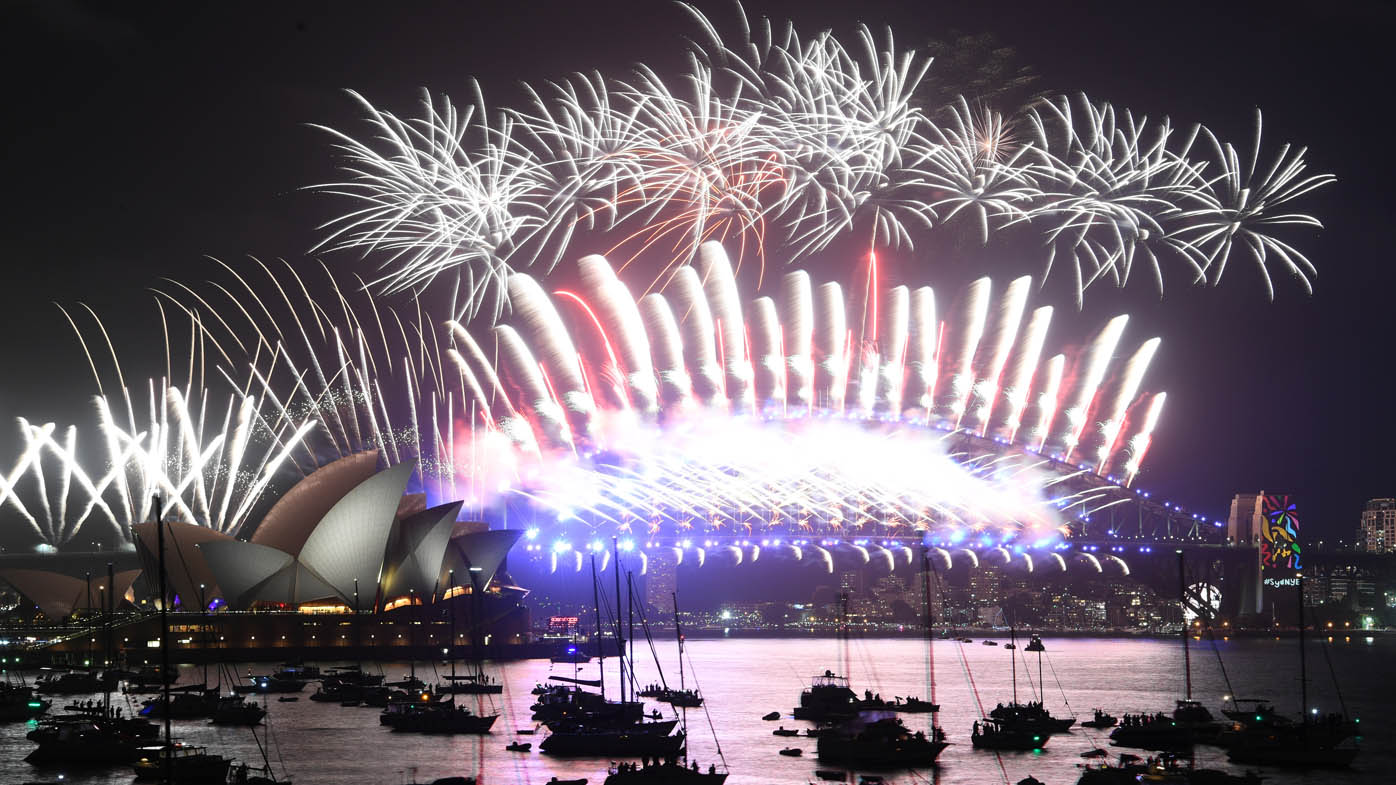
[0,451,529,654]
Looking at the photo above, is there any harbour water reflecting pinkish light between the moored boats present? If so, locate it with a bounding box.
[0,633,1396,785]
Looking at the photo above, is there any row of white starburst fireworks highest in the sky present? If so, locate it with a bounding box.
[311,8,1333,314]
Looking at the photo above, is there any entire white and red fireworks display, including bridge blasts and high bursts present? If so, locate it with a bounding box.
[10,3,1333,550]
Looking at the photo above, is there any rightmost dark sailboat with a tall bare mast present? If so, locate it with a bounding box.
[1227,573,1360,767]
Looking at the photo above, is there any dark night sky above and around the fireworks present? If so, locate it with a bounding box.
[0,0,1396,536]
